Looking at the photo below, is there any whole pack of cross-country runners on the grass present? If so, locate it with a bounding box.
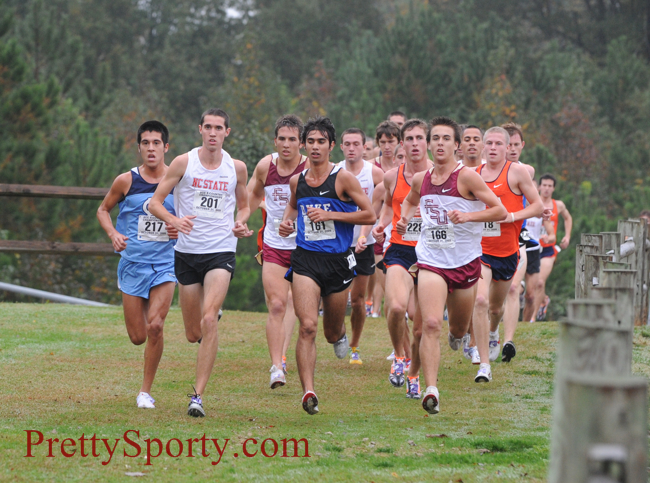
[97,109,571,417]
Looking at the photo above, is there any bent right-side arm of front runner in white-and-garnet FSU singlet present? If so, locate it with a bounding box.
[447,169,508,224]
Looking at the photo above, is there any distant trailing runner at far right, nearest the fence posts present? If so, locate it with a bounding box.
[537,174,573,320]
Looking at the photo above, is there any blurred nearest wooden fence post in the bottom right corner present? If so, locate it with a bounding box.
[549,374,648,483]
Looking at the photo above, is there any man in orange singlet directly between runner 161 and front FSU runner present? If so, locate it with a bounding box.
[373,119,432,397]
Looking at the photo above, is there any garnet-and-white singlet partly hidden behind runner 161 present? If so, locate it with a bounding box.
[264,156,307,250]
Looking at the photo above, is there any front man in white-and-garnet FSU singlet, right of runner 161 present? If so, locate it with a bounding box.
[395,117,507,414]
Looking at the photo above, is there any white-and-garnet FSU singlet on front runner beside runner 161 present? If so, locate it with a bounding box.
[415,163,485,268]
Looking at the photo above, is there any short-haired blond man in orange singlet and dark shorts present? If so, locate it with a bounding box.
[472,127,543,382]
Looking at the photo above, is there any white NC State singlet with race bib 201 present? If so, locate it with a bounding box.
[174,148,237,254]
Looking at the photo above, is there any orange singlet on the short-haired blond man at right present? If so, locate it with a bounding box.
[476,161,524,257]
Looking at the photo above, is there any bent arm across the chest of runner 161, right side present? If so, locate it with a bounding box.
[307,170,377,225]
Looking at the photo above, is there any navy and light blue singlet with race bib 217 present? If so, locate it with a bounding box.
[115,168,176,264]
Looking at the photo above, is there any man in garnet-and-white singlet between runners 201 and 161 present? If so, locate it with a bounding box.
[248,115,307,389]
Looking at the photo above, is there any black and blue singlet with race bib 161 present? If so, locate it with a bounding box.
[296,165,358,253]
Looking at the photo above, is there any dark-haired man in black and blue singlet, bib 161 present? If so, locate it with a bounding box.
[279,117,376,414]
